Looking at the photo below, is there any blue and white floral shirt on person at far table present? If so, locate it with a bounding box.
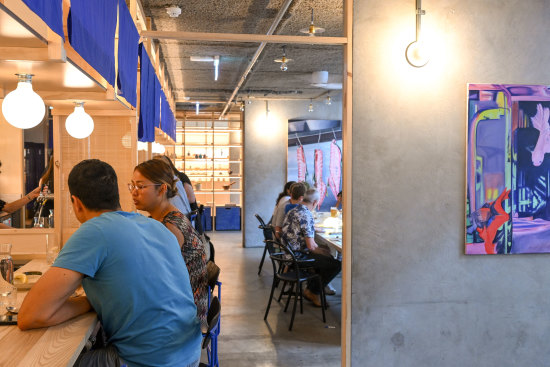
[283,204,315,252]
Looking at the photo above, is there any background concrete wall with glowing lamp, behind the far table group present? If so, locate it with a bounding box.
[244,95,342,247]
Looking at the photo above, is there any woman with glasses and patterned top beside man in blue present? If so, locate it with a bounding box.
[133,159,208,329]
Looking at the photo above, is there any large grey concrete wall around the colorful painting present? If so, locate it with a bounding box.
[352,0,550,367]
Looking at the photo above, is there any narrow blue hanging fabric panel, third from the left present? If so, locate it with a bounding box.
[117,1,139,107]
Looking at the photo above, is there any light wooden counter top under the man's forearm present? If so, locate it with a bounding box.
[0,259,97,367]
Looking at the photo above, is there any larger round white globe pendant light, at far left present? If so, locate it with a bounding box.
[2,74,46,129]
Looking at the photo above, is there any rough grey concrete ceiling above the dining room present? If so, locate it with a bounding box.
[142,0,343,108]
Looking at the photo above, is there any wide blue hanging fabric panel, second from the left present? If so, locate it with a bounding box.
[67,0,118,85]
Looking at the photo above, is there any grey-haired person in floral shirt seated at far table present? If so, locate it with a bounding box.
[282,189,342,307]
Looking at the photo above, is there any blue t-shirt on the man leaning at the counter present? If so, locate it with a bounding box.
[53,211,202,367]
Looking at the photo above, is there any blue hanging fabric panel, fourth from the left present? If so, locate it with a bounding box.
[138,43,156,142]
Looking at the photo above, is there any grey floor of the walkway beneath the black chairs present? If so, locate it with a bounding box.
[209,232,341,367]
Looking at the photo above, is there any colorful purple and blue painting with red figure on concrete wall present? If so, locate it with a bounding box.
[466,84,550,255]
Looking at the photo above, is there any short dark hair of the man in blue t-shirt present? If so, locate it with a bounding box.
[69,159,120,211]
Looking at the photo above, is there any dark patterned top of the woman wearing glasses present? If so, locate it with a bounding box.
[162,210,208,328]
